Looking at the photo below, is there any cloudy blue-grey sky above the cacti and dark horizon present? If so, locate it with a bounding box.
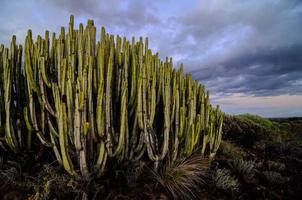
[0,0,302,117]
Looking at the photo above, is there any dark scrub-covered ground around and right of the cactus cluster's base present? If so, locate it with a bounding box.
[0,115,302,200]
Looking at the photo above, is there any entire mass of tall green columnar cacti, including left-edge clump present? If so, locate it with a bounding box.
[0,16,222,177]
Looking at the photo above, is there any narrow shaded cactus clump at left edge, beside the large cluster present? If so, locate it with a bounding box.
[0,36,27,153]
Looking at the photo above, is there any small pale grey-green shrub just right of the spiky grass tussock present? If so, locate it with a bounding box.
[212,169,239,191]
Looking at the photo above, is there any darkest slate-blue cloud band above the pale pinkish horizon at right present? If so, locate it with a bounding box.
[191,45,302,96]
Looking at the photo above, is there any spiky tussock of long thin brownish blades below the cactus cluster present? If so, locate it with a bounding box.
[150,155,209,199]
